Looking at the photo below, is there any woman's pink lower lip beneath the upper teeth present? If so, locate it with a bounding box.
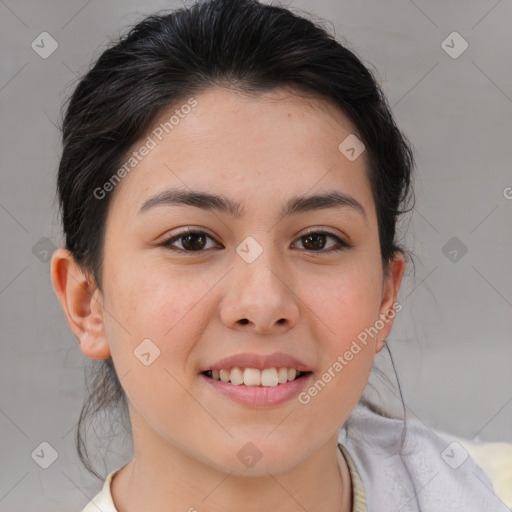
[199,373,313,407]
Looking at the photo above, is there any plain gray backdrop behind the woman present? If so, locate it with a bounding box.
[0,0,512,512]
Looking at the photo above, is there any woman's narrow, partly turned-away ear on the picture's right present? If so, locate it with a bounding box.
[375,252,405,352]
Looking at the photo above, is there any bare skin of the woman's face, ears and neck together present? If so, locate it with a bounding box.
[52,87,405,512]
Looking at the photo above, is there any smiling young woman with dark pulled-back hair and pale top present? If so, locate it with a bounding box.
[52,0,510,512]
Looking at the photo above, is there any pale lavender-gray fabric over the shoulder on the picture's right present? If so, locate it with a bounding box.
[339,404,509,512]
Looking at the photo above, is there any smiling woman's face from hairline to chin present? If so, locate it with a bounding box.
[53,88,403,474]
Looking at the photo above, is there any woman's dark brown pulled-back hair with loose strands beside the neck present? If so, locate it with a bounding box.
[57,0,414,479]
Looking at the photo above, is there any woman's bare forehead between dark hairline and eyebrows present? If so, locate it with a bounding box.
[111,87,373,222]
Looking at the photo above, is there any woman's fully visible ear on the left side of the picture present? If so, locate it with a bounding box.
[51,247,110,359]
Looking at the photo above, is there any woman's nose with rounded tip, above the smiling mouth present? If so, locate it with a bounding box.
[220,246,300,334]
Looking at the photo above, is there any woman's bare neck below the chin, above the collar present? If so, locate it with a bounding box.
[111,424,352,512]
